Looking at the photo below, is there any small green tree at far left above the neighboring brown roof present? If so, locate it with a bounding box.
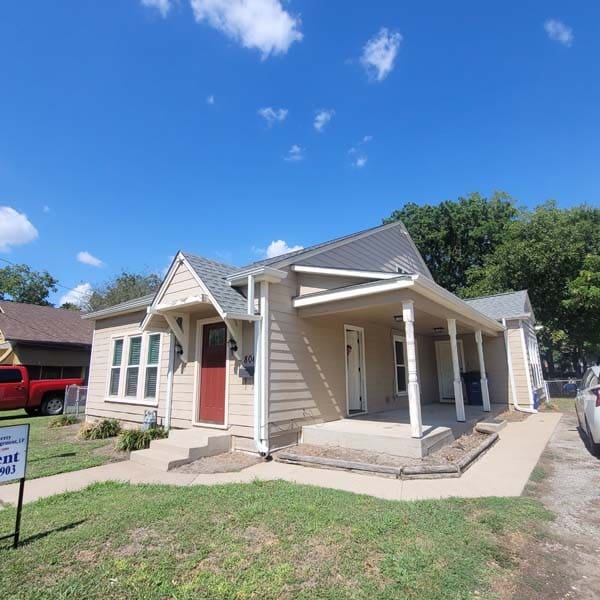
[0,264,58,306]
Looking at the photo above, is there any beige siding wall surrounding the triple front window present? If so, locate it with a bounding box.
[86,311,169,425]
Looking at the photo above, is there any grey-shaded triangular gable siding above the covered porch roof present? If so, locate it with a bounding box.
[298,227,430,277]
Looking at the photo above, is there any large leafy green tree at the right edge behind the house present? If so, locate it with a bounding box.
[462,202,600,368]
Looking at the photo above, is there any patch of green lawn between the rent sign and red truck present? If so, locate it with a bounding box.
[0,410,123,479]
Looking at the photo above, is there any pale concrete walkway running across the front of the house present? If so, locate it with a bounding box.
[0,413,561,504]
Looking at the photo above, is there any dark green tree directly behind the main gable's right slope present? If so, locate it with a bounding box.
[384,192,519,293]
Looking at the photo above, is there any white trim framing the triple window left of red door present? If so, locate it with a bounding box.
[104,331,163,408]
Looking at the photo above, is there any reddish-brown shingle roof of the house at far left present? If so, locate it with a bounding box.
[0,300,94,346]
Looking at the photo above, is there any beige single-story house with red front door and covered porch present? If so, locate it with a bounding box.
[85,222,544,453]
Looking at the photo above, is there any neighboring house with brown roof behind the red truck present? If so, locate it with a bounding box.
[0,300,94,379]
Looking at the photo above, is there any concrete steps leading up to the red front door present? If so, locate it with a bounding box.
[129,429,231,471]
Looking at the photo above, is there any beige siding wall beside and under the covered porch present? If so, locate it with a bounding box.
[269,272,437,443]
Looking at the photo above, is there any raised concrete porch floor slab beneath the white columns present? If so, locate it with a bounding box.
[302,403,507,458]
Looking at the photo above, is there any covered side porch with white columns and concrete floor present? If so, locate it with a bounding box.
[294,275,507,457]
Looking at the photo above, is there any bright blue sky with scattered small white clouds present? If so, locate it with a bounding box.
[0,0,600,302]
